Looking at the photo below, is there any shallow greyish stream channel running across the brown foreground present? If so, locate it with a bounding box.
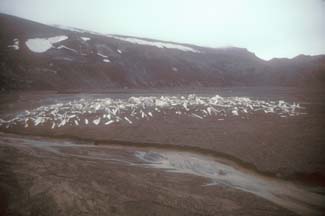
[1,134,325,215]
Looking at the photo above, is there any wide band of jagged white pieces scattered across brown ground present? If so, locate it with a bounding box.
[0,94,306,129]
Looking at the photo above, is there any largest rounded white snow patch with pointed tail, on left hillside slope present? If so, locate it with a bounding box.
[25,35,69,53]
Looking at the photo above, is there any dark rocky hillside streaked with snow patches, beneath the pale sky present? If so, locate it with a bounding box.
[0,14,325,91]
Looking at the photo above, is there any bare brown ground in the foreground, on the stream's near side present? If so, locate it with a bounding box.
[0,134,295,216]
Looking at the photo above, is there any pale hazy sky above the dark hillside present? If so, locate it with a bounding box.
[0,0,325,59]
